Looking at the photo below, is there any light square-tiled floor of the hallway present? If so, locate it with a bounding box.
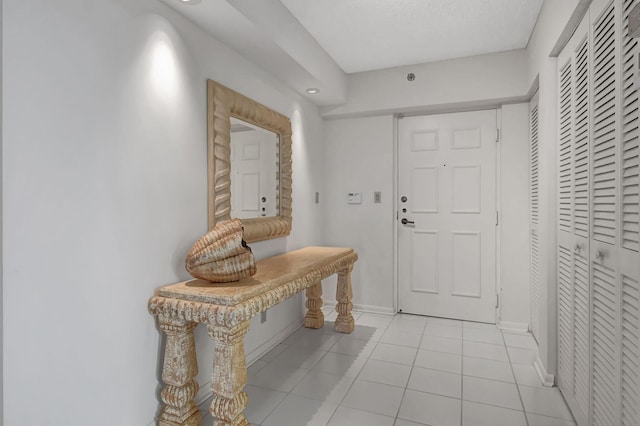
[204,309,575,426]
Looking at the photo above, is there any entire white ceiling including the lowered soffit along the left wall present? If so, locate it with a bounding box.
[160,0,543,106]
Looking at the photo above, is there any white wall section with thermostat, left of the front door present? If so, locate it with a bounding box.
[321,116,394,313]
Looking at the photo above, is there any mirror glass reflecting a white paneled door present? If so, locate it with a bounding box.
[231,117,280,219]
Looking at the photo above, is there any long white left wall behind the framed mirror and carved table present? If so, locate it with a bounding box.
[3,0,323,426]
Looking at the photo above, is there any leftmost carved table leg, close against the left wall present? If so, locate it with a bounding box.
[158,317,202,426]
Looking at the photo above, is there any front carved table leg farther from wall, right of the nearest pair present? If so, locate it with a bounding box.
[208,321,250,426]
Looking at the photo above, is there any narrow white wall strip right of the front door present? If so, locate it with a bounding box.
[498,103,531,330]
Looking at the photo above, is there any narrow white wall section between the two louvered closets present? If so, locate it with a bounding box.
[527,0,582,380]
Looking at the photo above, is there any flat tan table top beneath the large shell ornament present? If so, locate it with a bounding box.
[158,247,358,306]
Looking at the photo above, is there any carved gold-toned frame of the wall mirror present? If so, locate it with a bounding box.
[207,80,291,242]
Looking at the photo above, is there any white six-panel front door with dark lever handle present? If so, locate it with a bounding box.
[397,110,497,323]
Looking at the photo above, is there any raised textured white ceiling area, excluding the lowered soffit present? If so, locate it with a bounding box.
[281,0,543,73]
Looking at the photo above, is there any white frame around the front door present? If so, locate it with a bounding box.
[393,106,502,327]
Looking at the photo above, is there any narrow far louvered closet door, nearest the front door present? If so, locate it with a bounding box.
[529,93,540,339]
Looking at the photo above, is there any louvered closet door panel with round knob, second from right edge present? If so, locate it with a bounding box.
[590,1,622,426]
